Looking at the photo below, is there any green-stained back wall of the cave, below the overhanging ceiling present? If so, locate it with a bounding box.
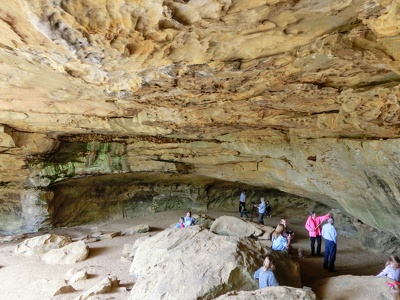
[2,136,399,244]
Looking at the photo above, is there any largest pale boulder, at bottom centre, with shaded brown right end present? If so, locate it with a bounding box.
[130,226,301,300]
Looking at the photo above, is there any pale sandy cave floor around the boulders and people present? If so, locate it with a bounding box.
[0,211,388,300]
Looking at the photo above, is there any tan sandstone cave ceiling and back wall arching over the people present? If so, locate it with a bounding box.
[0,0,400,238]
